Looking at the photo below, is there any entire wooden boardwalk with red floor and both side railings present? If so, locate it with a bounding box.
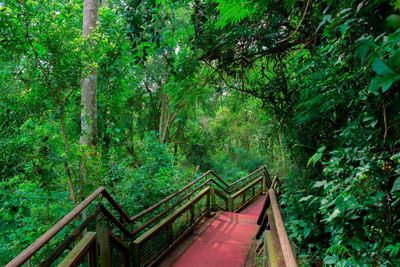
[6,166,297,267]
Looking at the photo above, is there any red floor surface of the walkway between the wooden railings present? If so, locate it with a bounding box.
[173,197,264,267]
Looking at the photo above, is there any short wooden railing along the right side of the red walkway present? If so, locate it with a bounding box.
[255,177,297,267]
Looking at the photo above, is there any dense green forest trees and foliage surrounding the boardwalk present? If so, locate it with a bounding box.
[0,0,400,266]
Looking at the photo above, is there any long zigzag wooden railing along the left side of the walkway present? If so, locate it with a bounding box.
[6,166,272,267]
